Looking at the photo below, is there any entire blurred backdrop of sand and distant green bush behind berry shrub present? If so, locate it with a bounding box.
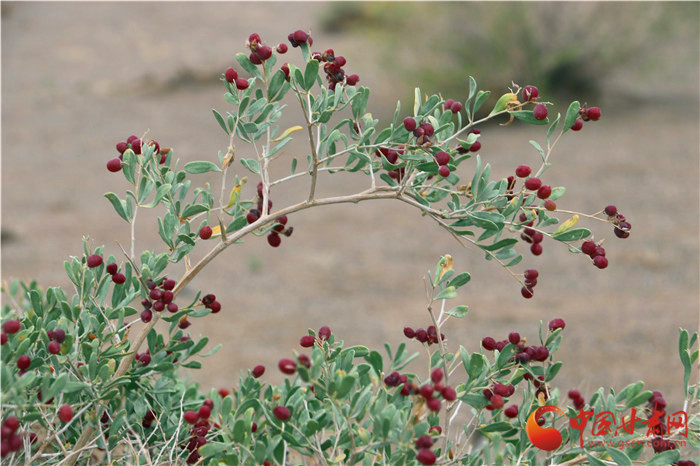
[2,2,700,410]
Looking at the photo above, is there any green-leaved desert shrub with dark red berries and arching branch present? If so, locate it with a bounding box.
[0,31,699,464]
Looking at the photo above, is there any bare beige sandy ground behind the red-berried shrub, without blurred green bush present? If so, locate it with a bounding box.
[2,3,700,409]
